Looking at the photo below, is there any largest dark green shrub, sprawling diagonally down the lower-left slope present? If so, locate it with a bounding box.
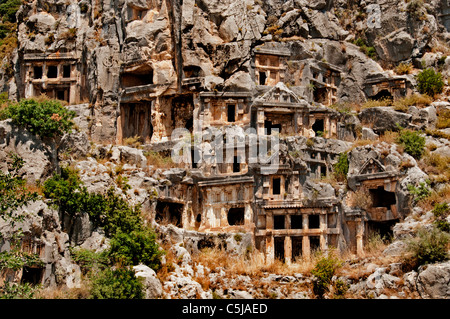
[43,167,163,271]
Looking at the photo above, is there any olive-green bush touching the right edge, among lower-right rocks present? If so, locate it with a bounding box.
[407,227,450,266]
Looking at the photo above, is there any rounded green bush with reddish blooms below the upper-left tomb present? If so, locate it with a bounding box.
[6,98,75,138]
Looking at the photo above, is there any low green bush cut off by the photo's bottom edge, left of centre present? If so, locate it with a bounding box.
[91,268,144,299]
